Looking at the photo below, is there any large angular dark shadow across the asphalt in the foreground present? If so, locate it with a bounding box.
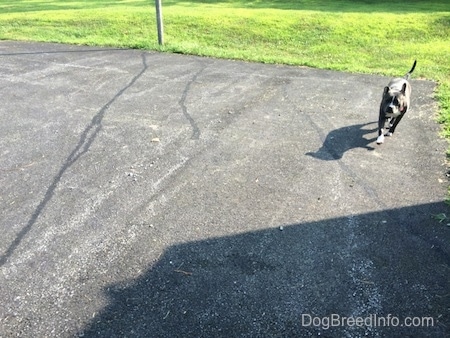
[79,203,450,337]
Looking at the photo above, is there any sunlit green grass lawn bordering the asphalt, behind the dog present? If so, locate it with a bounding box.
[0,0,450,151]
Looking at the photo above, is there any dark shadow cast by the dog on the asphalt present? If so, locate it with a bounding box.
[305,122,377,161]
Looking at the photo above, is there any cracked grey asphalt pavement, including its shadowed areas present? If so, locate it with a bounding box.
[0,41,450,337]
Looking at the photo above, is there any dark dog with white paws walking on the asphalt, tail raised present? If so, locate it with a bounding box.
[377,60,417,144]
